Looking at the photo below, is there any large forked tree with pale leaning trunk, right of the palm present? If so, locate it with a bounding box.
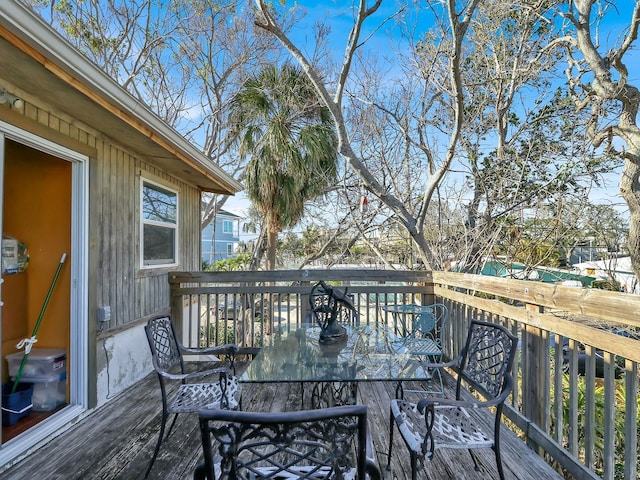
[256,0,603,270]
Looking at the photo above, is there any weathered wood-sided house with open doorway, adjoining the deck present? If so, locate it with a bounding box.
[0,0,241,471]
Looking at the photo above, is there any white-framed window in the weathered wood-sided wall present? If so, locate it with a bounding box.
[140,180,178,267]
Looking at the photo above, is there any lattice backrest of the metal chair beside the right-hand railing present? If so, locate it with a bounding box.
[458,320,518,398]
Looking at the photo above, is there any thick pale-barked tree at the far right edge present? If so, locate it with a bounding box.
[555,0,640,278]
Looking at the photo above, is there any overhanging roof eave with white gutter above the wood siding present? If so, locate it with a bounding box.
[0,0,243,194]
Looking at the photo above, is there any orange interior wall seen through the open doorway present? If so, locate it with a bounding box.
[1,141,71,382]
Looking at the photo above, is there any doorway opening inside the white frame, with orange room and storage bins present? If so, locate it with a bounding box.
[1,140,72,443]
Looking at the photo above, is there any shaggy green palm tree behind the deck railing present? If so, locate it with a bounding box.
[231,64,338,270]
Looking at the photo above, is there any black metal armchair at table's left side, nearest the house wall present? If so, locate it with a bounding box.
[145,316,240,478]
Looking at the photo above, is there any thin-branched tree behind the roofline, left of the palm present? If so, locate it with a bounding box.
[22,0,282,228]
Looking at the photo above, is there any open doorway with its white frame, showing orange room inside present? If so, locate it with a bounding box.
[0,122,88,457]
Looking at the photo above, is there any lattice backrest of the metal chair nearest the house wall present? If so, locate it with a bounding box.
[144,316,185,381]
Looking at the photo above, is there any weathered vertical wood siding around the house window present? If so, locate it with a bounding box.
[13,99,200,330]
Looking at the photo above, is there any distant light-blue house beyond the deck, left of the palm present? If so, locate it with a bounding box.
[202,210,241,264]
